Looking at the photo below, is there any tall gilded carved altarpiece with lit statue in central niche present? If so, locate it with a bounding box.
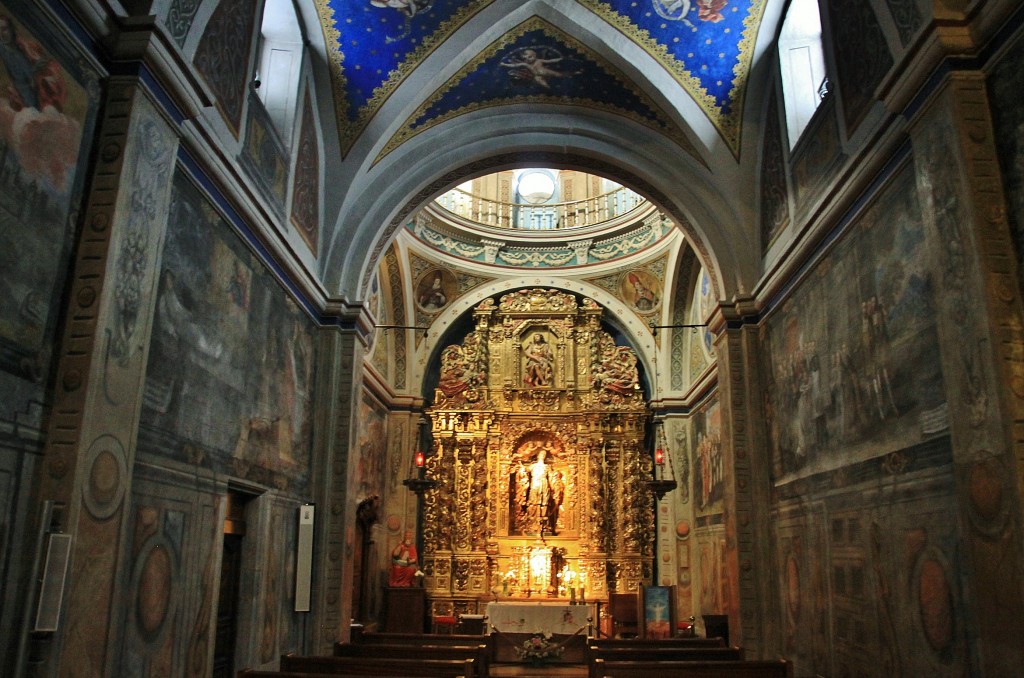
[422,290,654,616]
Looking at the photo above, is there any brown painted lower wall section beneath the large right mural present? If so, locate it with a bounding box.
[773,436,969,677]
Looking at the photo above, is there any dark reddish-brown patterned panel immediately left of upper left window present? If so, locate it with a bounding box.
[194,0,259,136]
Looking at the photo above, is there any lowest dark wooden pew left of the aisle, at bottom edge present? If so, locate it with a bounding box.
[281,654,479,678]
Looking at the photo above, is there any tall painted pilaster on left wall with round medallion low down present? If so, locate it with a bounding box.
[26,79,178,676]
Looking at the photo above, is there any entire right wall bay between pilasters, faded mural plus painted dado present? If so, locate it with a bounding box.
[762,155,967,676]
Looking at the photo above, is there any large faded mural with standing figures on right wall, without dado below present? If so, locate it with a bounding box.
[762,161,948,476]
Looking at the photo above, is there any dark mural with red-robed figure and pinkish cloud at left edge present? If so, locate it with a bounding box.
[0,5,97,424]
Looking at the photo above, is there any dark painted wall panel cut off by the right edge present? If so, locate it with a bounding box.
[988,32,1024,294]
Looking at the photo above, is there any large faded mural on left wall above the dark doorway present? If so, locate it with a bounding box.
[140,168,313,490]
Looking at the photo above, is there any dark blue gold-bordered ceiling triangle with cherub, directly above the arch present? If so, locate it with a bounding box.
[375,16,703,164]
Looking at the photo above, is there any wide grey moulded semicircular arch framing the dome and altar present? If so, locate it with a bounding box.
[324,126,745,313]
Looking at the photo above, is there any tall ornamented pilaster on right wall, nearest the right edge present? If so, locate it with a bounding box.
[910,72,1024,676]
